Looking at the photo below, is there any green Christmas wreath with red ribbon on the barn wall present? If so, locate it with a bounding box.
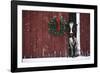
[48,16,66,35]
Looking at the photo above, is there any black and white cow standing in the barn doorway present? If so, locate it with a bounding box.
[66,21,78,57]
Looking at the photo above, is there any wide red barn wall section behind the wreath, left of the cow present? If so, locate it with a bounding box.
[22,11,69,58]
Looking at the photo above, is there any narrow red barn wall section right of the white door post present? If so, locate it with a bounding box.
[80,13,90,56]
